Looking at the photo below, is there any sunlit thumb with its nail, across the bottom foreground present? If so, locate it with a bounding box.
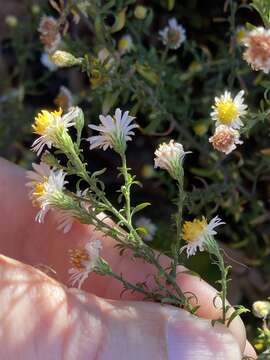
[0,256,241,360]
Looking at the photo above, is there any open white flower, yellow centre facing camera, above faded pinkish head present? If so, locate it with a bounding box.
[211,90,247,129]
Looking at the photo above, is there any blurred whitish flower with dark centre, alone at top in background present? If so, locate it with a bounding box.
[159,18,186,50]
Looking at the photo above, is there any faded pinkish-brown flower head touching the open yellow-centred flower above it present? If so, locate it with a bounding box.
[209,125,243,155]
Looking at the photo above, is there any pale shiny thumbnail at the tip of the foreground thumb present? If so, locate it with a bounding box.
[166,310,242,360]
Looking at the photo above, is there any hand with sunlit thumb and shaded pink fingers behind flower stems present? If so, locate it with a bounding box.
[0,159,256,360]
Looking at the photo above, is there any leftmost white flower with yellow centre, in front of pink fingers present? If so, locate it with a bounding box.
[26,163,67,223]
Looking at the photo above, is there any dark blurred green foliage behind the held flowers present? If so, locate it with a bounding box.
[0,0,270,354]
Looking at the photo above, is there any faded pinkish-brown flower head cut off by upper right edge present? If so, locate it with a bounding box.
[243,27,270,74]
